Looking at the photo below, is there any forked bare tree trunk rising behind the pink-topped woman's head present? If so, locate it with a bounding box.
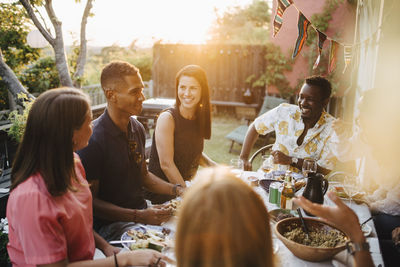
[20,0,93,87]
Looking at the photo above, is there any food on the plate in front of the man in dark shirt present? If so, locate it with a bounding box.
[122,226,172,252]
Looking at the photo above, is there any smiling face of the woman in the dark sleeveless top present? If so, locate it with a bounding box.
[178,76,201,110]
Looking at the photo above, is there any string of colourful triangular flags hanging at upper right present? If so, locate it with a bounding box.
[273,0,375,73]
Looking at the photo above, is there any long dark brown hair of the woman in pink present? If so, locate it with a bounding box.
[11,88,90,196]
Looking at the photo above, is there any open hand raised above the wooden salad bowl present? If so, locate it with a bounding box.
[294,192,364,242]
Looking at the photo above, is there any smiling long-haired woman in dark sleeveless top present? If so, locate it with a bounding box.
[146,65,215,203]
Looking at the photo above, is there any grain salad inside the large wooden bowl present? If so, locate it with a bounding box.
[283,224,347,248]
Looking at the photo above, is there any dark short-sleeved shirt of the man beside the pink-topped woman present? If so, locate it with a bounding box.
[78,110,147,229]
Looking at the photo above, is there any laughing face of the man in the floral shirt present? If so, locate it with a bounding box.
[298,83,329,122]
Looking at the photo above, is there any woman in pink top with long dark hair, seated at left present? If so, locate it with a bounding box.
[7,88,169,266]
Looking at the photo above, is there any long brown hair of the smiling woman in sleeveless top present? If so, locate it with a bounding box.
[175,65,211,139]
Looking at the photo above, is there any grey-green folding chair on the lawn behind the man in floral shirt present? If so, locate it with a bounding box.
[225,95,287,153]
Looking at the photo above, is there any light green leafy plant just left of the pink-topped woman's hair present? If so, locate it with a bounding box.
[8,94,33,143]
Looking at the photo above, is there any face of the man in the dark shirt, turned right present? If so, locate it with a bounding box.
[109,73,146,117]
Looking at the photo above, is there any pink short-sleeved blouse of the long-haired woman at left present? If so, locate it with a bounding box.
[7,154,95,266]
